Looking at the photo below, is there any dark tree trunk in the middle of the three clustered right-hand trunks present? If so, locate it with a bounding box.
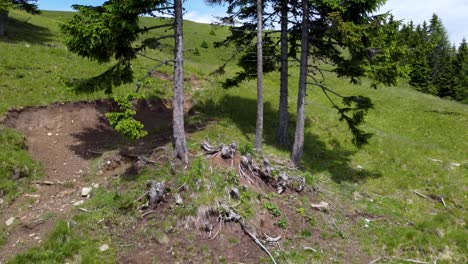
[277,0,289,146]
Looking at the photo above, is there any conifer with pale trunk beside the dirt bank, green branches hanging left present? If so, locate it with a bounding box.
[61,0,188,164]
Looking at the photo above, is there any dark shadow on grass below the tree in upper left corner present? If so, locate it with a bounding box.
[0,17,53,44]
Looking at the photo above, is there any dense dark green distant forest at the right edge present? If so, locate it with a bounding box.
[398,14,468,103]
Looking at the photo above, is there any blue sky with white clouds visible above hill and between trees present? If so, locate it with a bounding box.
[38,0,468,45]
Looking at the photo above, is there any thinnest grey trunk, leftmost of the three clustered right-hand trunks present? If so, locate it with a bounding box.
[255,0,263,151]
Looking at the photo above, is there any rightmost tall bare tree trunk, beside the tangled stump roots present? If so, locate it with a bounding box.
[291,0,309,166]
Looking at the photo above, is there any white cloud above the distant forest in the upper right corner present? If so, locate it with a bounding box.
[380,0,468,45]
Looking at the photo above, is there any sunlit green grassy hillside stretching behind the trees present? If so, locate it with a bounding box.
[0,11,468,263]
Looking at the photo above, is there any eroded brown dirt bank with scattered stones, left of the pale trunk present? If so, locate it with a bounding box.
[0,100,177,261]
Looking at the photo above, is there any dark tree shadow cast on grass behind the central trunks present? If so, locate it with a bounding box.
[194,95,381,183]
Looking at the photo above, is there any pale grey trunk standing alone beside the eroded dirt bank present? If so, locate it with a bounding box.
[173,0,188,164]
